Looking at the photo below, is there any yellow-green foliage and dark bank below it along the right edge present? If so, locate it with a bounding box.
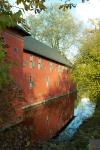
[59,21,100,150]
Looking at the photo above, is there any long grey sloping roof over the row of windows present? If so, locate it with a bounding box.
[24,36,72,67]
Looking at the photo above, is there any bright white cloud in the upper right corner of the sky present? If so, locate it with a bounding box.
[76,0,100,22]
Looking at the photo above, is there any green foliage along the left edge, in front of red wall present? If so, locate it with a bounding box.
[0,0,22,89]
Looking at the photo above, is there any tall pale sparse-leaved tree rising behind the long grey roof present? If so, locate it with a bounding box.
[28,4,80,51]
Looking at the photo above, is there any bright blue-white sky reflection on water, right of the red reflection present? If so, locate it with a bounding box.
[56,98,95,141]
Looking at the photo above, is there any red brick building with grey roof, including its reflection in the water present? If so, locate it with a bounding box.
[3,26,76,140]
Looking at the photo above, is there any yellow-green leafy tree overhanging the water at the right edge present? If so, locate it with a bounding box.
[73,29,100,100]
